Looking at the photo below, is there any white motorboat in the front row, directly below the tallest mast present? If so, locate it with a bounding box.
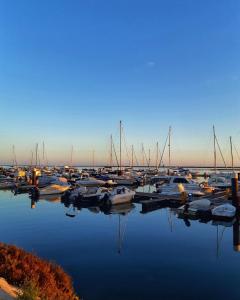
[107,186,135,205]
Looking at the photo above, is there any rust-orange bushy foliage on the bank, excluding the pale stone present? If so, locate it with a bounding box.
[0,243,77,300]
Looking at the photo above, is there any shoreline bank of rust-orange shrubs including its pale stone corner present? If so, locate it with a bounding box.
[0,242,79,300]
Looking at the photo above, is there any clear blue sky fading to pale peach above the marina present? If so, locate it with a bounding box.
[0,0,240,165]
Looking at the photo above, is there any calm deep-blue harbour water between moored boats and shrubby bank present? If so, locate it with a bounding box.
[0,191,240,300]
